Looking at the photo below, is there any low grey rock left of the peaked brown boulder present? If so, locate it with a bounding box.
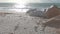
[27,9,44,17]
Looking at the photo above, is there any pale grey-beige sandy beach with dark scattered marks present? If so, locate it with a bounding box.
[0,13,57,34]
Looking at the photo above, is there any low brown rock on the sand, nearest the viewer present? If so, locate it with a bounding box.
[42,15,60,31]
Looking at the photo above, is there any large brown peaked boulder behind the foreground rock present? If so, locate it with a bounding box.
[45,5,60,18]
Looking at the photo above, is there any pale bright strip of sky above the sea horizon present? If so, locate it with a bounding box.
[0,0,60,3]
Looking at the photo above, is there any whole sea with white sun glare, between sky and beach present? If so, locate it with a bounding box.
[0,3,60,12]
